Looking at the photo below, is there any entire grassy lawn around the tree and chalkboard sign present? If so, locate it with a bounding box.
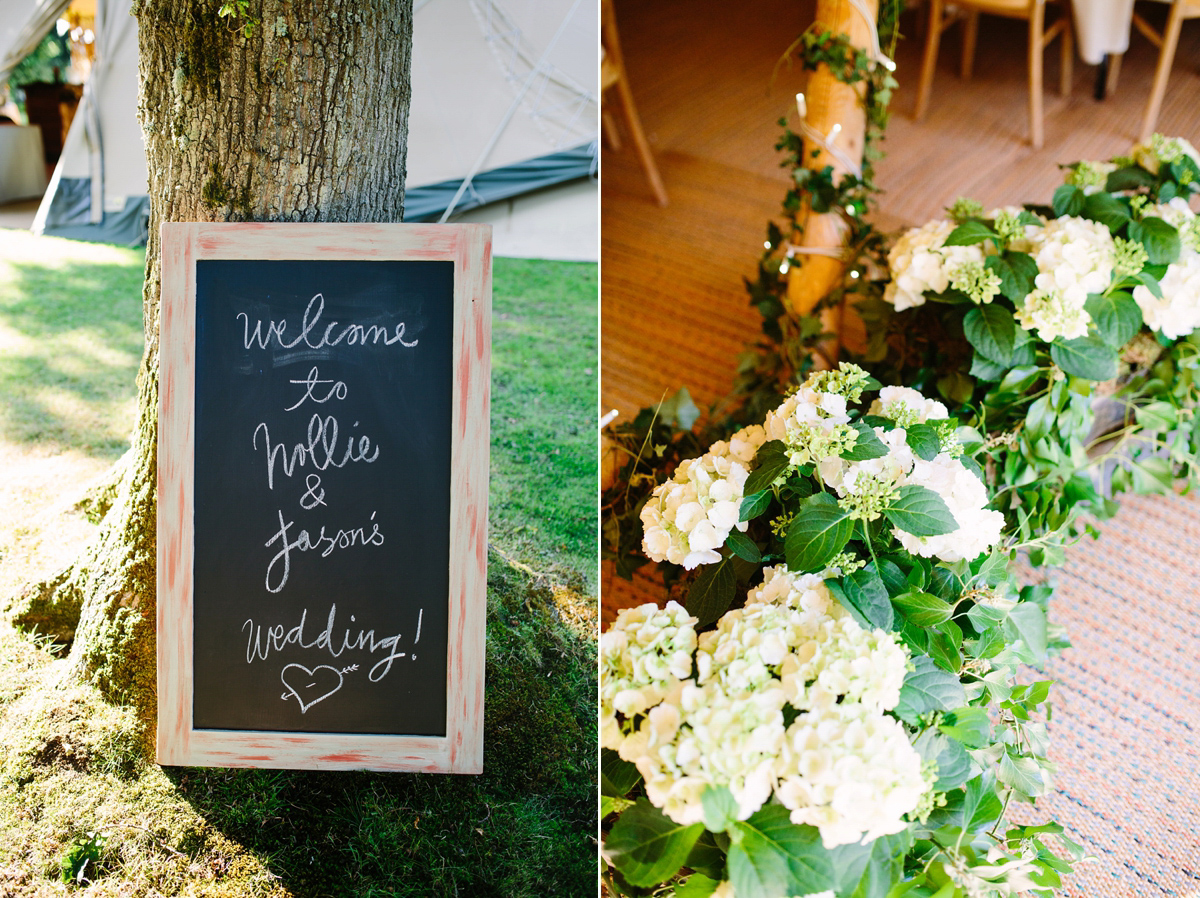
[0,231,596,898]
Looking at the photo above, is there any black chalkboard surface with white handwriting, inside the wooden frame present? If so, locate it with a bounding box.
[193,259,454,735]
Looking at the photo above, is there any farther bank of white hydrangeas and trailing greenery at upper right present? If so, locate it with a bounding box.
[859,134,1200,563]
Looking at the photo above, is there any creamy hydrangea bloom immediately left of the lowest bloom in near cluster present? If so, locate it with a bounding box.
[619,680,785,826]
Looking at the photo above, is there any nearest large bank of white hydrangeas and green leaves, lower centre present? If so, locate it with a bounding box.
[600,364,1080,898]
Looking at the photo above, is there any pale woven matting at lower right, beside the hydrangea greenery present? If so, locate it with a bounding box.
[1021,496,1200,898]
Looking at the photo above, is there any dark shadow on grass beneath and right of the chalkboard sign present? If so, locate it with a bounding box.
[154,556,596,898]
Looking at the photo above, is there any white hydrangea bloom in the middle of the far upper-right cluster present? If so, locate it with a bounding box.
[1033,215,1116,315]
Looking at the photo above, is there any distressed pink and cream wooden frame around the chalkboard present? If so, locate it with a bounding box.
[157,222,492,773]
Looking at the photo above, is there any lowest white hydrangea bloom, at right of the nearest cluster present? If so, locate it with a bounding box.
[775,702,932,849]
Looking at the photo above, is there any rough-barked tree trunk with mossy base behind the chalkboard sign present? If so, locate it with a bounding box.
[9,0,413,737]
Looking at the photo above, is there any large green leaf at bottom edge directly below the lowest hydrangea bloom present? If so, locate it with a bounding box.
[728,804,834,898]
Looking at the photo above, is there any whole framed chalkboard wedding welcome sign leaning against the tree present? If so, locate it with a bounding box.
[158,223,491,773]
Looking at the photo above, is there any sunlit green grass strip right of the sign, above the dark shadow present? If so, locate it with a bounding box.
[491,259,599,593]
